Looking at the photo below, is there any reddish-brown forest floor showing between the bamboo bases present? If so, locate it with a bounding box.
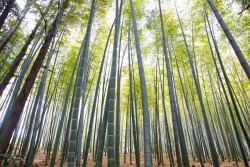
[33,151,248,167]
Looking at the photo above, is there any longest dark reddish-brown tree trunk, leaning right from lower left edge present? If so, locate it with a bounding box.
[0,0,68,157]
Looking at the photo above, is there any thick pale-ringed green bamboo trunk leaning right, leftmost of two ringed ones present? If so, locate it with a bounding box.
[67,0,96,167]
